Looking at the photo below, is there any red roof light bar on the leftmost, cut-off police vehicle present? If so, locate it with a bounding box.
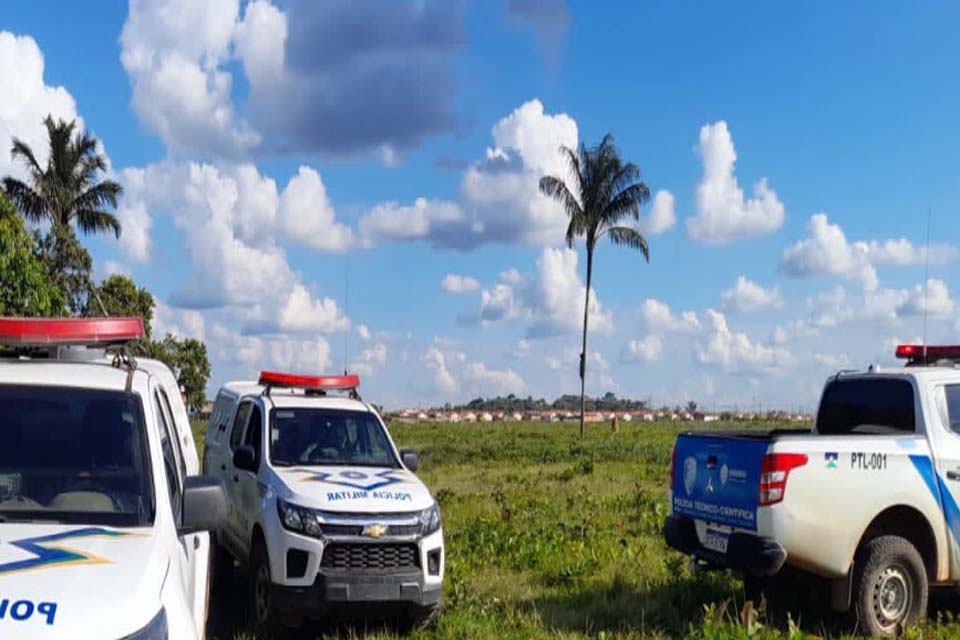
[0,318,146,347]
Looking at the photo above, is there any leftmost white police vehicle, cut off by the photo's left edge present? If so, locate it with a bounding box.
[0,318,226,640]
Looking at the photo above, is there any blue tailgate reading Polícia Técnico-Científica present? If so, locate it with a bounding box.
[673,433,770,531]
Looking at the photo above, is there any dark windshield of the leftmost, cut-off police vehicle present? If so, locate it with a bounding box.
[0,385,154,526]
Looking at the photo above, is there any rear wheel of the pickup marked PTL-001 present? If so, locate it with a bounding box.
[853,536,927,638]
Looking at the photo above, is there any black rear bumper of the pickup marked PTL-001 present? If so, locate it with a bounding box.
[663,516,787,576]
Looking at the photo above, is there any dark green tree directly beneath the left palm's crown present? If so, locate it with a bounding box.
[34,225,96,316]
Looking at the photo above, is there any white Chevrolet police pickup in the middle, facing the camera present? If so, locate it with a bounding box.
[204,372,445,629]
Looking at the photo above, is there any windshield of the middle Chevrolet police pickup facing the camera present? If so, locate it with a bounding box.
[270,408,399,467]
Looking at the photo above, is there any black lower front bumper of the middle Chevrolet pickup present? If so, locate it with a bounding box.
[273,571,443,617]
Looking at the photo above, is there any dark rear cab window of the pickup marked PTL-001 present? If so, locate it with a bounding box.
[817,378,916,435]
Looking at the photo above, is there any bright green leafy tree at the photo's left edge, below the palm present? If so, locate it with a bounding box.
[0,194,66,317]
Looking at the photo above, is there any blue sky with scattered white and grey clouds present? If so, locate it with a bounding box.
[0,0,960,408]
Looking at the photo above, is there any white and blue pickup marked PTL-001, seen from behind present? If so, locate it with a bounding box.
[664,345,960,636]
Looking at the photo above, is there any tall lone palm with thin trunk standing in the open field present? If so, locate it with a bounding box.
[540,134,650,438]
